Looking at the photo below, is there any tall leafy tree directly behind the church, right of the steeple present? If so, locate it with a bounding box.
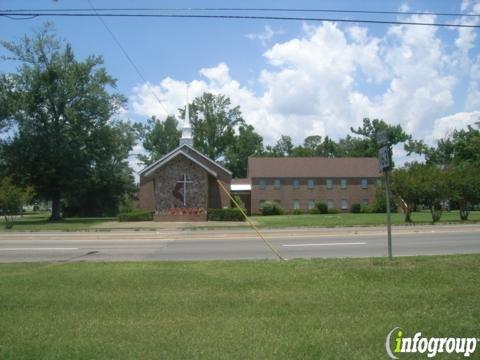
[179,93,244,161]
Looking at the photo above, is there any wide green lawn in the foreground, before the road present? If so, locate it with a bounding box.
[0,255,480,359]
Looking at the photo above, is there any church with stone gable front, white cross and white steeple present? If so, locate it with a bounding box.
[138,100,232,221]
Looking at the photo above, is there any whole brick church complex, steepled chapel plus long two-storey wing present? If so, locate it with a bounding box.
[138,99,380,221]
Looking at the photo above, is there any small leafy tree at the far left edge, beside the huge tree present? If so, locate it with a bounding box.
[0,177,34,229]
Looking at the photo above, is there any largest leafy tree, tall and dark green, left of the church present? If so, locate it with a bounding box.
[0,24,126,220]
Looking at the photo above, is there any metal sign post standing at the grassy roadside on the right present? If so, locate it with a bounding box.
[377,131,393,260]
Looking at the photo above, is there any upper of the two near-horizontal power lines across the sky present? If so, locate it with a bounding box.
[2,7,480,17]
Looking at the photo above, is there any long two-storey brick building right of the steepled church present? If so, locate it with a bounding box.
[231,157,380,214]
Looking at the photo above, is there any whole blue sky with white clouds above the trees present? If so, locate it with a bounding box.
[0,0,480,170]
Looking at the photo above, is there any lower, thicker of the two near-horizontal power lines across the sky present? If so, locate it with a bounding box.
[0,12,480,28]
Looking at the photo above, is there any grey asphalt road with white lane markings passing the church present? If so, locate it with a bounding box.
[0,225,480,262]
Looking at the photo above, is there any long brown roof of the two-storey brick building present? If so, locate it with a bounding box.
[248,157,380,178]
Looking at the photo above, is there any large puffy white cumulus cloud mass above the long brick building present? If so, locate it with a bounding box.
[131,8,480,166]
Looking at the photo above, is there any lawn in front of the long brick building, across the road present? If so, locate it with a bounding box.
[252,211,480,228]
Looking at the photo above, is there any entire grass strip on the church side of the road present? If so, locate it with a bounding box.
[0,211,480,231]
